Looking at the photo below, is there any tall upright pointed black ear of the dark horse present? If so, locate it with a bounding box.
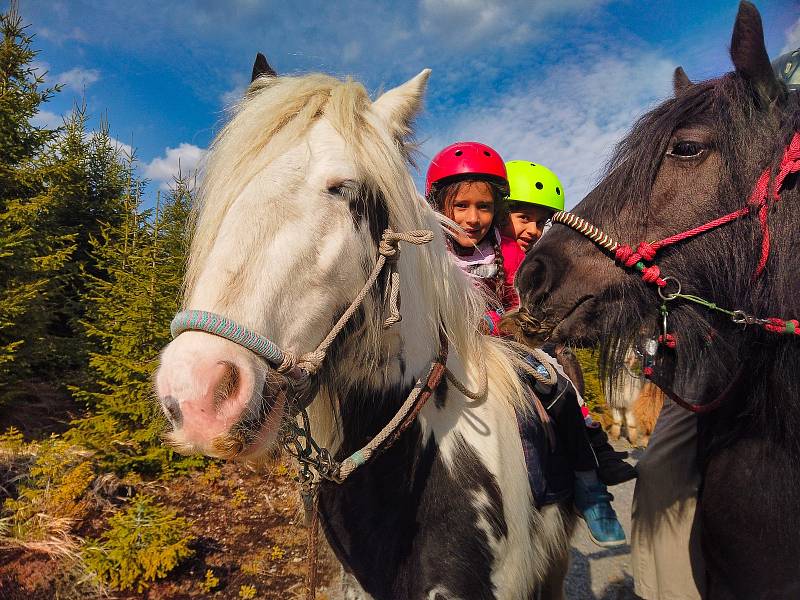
[731,1,784,107]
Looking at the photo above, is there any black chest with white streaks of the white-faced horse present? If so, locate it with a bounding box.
[322,432,508,600]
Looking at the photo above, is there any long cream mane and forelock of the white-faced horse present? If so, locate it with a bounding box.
[186,74,526,440]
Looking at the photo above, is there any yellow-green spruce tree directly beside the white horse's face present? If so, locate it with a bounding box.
[69,171,199,473]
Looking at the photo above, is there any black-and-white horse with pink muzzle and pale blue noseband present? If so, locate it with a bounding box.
[156,57,573,600]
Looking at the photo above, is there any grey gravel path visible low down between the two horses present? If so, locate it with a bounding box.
[566,440,642,600]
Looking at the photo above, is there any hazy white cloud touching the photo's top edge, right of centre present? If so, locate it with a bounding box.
[420,0,605,48]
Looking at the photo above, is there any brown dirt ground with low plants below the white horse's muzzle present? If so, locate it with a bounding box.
[0,464,339,600]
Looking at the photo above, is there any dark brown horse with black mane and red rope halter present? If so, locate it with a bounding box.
[517,2,800,599]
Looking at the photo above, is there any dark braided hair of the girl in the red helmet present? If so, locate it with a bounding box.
[428,173,508,305]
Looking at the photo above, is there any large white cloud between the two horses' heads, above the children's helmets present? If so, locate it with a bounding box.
[424,48,674,207]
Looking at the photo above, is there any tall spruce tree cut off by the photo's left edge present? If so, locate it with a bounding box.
[0,4,73,398]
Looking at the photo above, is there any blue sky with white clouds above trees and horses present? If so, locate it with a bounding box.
[19,0,800,205]
